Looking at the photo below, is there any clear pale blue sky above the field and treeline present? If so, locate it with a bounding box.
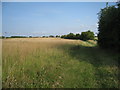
[2,2,115,36]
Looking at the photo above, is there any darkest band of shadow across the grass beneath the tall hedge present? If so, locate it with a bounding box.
[65,45,119,67]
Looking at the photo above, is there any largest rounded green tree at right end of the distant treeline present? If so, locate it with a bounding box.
[80,30,95,41]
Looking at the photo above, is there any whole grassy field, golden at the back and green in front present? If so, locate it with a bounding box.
[2,38,120,88]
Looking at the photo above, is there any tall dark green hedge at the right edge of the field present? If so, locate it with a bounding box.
[98,2,120,50]
